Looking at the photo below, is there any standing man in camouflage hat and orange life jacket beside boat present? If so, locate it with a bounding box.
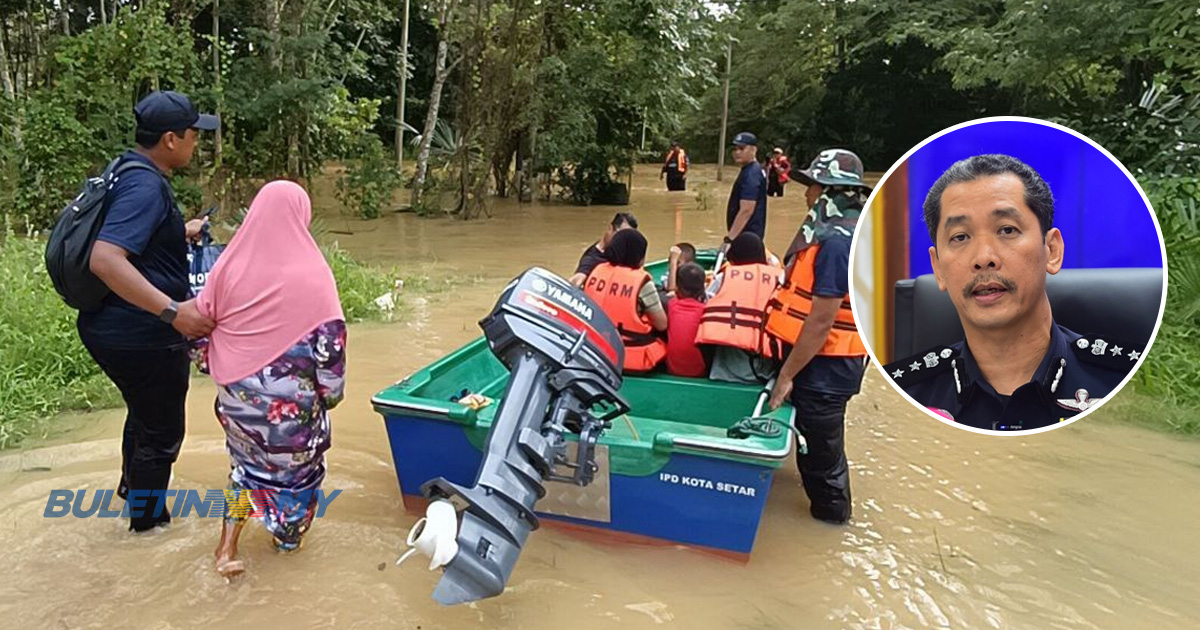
[767,149,870,523]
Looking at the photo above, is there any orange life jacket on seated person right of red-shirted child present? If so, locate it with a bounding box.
[696,263,780,359]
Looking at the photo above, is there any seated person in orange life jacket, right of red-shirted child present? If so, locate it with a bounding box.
[696,232,782,383]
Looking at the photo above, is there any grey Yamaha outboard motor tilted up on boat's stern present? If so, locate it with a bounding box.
[402,268,629,605]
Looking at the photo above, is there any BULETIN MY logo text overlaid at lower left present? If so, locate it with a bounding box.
[42,490,342,518]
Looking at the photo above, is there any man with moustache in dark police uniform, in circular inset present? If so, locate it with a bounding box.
[886,155,1142,431]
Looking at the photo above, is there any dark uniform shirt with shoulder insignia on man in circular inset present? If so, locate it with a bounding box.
[884,324,1144,431]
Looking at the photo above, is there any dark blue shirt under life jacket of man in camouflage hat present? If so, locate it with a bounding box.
[792,233,866,396]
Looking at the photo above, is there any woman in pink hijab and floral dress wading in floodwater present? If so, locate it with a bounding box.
[196,181,346,577]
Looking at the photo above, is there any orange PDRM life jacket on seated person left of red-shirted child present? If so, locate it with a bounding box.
[583,263,667,372]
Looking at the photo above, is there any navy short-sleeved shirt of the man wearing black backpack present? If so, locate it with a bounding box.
[78,151,188,349]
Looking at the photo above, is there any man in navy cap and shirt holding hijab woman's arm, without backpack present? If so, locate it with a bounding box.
[75,91,218,532]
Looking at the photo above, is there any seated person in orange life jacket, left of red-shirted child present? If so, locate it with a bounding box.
[583,229,667,372]
